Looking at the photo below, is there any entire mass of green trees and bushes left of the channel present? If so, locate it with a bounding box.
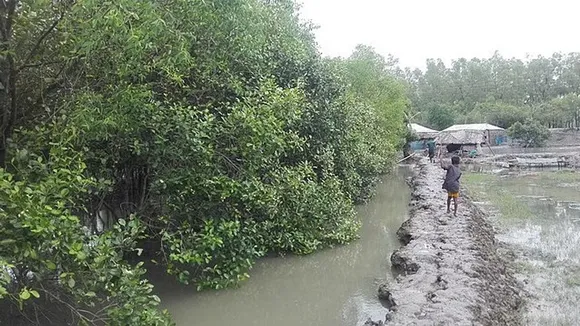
[0,0,408,325]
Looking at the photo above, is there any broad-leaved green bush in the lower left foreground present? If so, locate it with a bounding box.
[0,125,168,325]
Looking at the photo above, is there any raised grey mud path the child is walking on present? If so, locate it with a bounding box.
[368,159,522,325]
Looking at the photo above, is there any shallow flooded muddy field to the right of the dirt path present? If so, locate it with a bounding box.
[466,171,580,325]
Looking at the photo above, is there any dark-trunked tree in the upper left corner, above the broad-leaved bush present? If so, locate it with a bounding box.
[0,0,74,167]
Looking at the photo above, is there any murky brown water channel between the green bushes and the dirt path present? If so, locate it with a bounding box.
[152,168,410,326]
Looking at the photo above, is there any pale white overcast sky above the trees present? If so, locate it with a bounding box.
[298,0,580,68]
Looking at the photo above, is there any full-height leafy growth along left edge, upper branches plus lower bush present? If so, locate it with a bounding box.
[0,0,170,325]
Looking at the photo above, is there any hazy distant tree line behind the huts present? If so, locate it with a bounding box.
[399,53,580,129]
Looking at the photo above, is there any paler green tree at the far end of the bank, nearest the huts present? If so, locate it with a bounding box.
[336,45,408,201]
